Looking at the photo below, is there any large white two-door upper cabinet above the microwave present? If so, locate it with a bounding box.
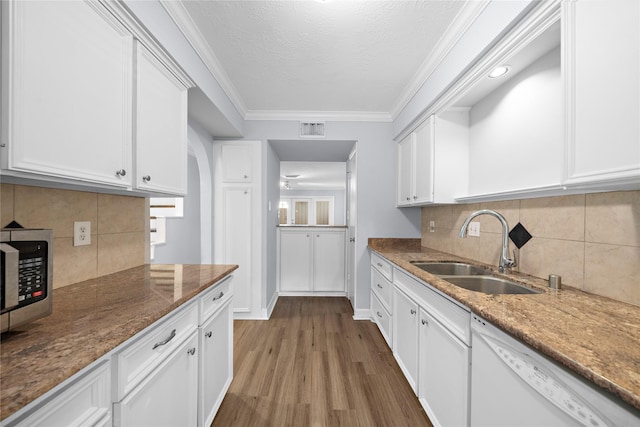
[0,1,192,195]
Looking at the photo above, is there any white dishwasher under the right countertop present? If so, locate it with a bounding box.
[471,314,640,427]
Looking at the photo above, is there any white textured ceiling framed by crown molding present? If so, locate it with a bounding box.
[169,0,466,117]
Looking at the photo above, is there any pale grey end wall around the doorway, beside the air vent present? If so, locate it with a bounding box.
[245,120,420,315]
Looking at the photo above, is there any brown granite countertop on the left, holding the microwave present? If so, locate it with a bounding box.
[0,264,238,419]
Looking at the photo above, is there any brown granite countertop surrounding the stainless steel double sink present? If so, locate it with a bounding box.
[369,239,640,409]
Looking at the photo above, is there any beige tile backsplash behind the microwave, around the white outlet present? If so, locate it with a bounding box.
[0,184,149,288]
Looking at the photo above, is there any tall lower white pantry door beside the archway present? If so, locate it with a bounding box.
[222,187,253,312]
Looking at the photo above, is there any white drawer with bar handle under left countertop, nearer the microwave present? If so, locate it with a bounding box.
[112,304,198,402]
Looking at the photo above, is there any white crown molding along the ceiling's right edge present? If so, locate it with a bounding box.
[390,0,491,120]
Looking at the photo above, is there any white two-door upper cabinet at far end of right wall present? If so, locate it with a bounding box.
[398,111,469,206]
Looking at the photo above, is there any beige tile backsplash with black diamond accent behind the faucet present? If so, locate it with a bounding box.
[422,191,640,305]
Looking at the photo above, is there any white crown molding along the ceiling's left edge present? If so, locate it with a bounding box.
[159,0,247,117]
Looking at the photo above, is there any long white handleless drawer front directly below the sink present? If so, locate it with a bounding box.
[393,269,471,345]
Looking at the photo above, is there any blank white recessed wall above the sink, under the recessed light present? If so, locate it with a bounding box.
[469,47,564,195]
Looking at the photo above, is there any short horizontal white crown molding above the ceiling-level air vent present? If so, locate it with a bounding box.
[245,110,392,123]
